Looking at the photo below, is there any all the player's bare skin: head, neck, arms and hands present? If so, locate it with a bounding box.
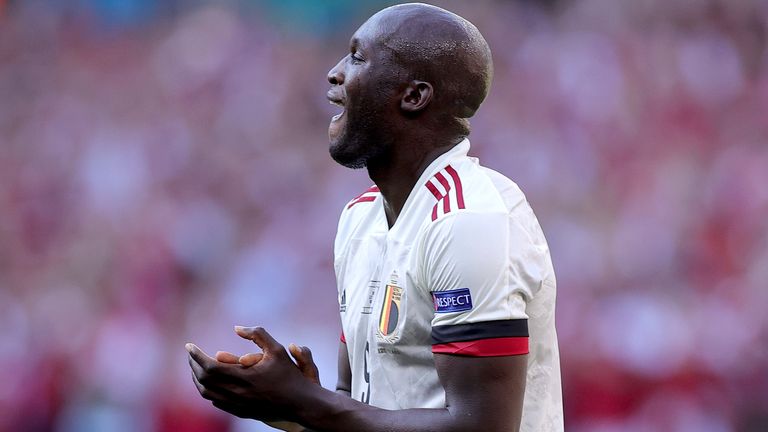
[187,4,528,432]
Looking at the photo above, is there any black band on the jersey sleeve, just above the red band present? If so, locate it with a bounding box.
[432,318,528,344]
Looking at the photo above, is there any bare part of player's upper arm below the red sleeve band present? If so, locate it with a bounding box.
[435,354,528,431]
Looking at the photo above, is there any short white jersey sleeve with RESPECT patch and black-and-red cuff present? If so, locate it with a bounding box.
[421,212,537,357]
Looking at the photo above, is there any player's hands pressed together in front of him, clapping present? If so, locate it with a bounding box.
[186,326,320,422]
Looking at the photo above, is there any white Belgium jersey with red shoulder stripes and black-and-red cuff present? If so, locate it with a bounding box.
[334,140,563,432]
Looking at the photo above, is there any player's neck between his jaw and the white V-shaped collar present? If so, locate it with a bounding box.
[368,138,463,228]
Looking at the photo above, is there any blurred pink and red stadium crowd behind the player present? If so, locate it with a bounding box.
[0,0,768,432]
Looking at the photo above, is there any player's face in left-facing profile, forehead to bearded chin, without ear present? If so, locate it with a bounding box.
[328,16,397,168]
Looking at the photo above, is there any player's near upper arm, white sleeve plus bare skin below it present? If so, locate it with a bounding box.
[422,212,541,431]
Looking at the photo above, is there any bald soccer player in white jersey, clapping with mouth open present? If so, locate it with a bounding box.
[187,4,563,432]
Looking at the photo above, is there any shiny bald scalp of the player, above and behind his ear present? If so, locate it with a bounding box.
[364,3,493,135]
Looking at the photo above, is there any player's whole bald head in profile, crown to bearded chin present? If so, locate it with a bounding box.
[327,3,493,171]
